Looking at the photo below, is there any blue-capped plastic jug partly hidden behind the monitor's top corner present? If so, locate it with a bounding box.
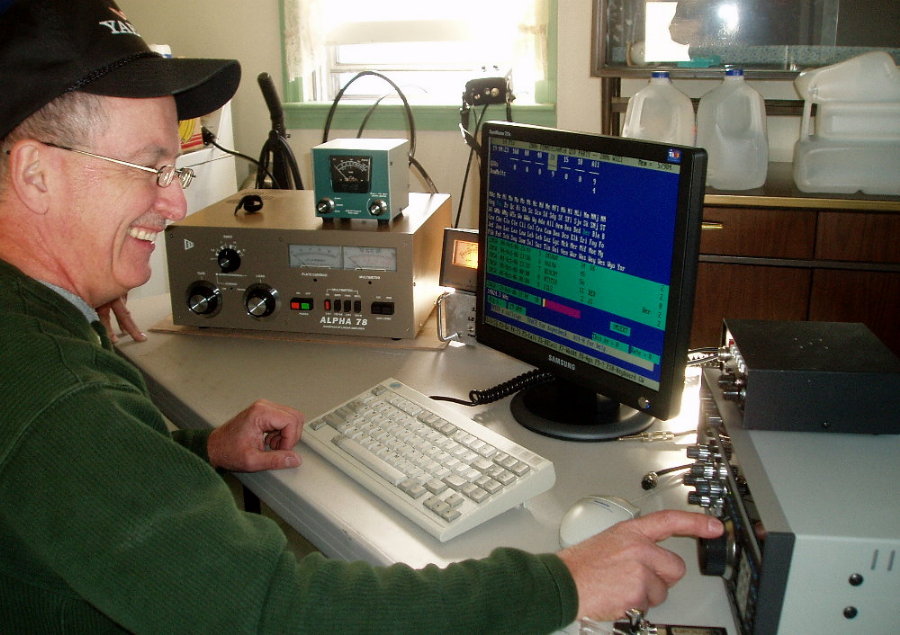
[622,71,695,146]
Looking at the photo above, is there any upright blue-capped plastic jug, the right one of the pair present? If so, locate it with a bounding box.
[697,69,769,190]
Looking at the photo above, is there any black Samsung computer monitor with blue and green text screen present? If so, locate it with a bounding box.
[475,122,706,441]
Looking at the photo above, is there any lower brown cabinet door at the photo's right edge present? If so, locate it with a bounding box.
[808,269,900,356]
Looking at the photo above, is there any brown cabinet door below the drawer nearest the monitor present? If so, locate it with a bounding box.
[691,262,812,348]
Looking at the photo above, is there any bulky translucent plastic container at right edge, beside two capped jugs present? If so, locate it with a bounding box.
[794,51,900,195]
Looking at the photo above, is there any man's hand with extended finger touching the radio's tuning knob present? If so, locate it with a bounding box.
[558,510,723,621]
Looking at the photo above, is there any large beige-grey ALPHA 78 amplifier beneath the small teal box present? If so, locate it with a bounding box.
[165,190,450,339]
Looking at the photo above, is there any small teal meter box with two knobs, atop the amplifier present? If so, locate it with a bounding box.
[312,138,409,222]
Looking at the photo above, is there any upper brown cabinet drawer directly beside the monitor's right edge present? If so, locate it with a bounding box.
[700,206,816,259]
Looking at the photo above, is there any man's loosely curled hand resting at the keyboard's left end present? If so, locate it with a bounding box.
[207,399,303,472]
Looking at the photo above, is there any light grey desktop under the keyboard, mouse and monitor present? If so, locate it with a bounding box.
[119,296,735,633]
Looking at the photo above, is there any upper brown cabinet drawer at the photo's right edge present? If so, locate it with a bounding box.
[816,212,900,262]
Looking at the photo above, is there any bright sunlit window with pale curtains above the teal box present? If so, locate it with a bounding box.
[283,0,553,107]
